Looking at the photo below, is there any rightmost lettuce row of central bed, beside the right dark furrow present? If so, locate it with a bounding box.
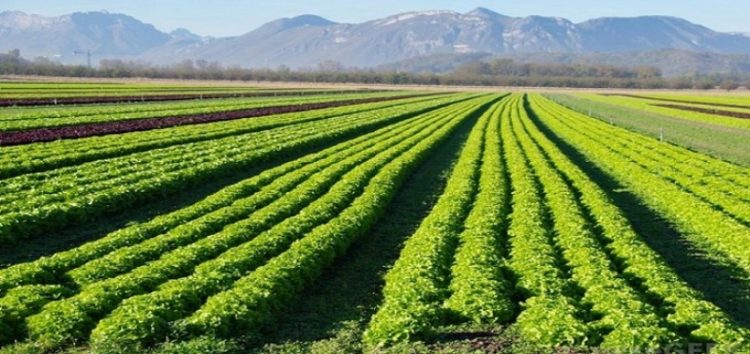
[523,94,750,350]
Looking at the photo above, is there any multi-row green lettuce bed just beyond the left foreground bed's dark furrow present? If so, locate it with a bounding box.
[0,94,470,241]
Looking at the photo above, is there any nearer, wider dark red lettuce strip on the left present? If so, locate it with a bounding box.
[0,94,433,146]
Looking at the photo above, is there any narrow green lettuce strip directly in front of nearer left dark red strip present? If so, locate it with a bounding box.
[0,97,450,178]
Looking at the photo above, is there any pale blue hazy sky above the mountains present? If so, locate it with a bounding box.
[0,0,750,36]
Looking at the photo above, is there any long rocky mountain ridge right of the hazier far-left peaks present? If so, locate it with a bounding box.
[154,8,750,67]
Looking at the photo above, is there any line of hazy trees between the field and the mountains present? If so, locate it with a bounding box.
[0,50,750,90]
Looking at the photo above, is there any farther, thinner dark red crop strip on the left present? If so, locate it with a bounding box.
[0,90,380,107]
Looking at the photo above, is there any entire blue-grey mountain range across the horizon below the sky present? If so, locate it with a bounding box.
[0,8,750,74]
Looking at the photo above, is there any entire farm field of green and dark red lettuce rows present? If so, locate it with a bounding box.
[0,83,750,354]
